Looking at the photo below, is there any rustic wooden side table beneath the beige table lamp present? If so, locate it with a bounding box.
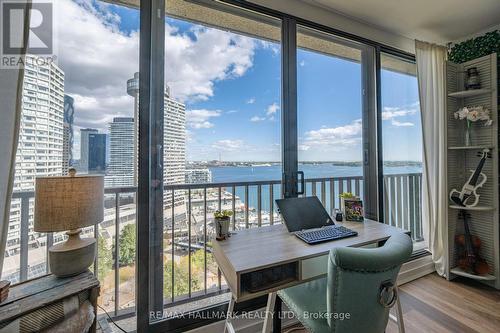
[0,271,100,332]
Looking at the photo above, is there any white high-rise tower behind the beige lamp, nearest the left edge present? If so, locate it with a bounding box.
[4,55,64,277]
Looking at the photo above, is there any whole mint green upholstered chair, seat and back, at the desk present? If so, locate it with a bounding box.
[278,234,413,333]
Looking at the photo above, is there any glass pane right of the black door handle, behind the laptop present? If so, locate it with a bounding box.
[296,26,371,217]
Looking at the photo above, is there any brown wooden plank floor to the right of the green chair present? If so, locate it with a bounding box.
[283,274,500,333]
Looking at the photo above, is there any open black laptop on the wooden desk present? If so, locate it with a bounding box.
[276,196,358,244]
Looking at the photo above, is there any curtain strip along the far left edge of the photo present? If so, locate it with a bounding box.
[0,1,31,273]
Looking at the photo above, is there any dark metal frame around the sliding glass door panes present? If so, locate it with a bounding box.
[136,0,415,332]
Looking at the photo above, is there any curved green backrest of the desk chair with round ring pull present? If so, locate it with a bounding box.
[326,234,412,333]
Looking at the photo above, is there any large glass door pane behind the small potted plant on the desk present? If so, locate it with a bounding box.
[162,1,282,312]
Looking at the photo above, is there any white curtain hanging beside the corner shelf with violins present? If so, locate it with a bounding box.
[415,41,448,276]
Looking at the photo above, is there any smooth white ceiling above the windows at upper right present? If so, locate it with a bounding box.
[303,0,500,43]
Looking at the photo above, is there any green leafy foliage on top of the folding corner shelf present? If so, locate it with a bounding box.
[448,30,500,64]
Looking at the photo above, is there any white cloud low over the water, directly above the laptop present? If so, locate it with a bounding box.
[299,119,362,151]
